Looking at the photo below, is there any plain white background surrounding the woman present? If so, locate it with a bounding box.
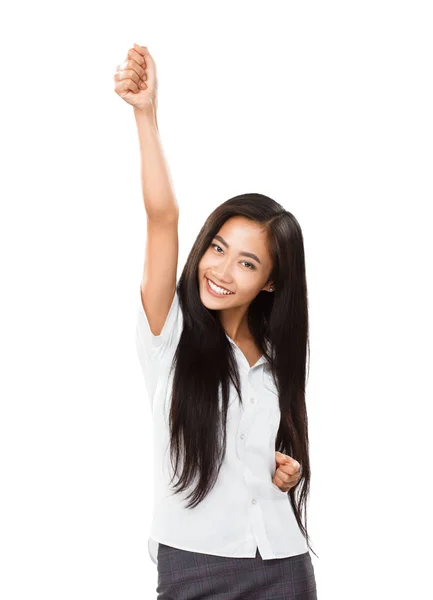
[0,0,433,600]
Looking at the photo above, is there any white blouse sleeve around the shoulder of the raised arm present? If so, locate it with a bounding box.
[136,288,183,406]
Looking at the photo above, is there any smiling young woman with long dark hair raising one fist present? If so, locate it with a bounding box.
[114,44,317,600]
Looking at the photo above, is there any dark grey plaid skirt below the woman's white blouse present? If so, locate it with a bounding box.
[156,543,317,600]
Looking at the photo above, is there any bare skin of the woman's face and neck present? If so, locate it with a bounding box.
[198,216,273,343]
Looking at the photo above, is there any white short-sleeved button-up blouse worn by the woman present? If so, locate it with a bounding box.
[136,284,308,564]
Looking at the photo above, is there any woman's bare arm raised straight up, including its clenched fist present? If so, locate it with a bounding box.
[115,44,179,335]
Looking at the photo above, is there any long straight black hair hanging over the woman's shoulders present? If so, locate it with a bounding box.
[165,193,317,556]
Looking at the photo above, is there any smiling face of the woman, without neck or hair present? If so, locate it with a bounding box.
[198,216,272,310]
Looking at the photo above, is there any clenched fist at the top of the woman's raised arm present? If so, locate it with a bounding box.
[114,44,158,112]
